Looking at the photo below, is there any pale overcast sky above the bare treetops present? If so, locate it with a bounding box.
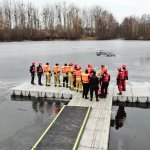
[20,0,150,22]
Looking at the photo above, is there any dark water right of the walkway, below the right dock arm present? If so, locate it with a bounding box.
[109,106,150,150]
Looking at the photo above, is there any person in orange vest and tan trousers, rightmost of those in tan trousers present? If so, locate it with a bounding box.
[75,66,82,92]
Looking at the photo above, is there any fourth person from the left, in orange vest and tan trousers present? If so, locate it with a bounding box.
[53,64,61,87]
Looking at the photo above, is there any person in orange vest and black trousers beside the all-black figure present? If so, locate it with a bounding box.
[81,70,90,99]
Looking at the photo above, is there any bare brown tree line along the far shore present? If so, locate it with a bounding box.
[0,0,150,41]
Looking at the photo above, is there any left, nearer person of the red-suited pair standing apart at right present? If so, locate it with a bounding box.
[116,67,124,95]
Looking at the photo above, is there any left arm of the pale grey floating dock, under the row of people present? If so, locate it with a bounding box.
[11,83,76,101]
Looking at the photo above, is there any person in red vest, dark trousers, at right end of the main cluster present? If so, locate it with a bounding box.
[100,69,110,98]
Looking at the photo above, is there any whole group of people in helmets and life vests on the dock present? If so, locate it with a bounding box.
[30,62,128,101]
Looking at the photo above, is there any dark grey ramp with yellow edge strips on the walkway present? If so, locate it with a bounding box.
[31,106,91,150]
